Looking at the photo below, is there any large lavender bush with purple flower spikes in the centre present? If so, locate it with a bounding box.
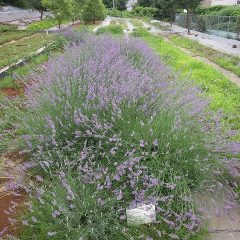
[2,32,240,239]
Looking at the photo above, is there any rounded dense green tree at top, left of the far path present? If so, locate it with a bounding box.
[83,0,106,23]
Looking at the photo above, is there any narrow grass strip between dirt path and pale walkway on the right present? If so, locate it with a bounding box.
[169,35,240,77]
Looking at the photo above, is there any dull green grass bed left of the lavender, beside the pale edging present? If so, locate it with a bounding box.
[0,33,52,68]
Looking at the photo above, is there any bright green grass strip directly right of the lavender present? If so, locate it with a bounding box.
[133,29,240,135]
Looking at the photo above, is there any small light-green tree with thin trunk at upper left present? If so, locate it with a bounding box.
[42,0,72,29]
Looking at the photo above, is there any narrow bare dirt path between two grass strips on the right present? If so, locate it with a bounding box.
[141,21,240,87]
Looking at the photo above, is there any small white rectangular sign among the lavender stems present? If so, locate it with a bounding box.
[126,204,156,225]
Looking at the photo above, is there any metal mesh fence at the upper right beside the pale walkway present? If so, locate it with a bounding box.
[175,14,240,40]
